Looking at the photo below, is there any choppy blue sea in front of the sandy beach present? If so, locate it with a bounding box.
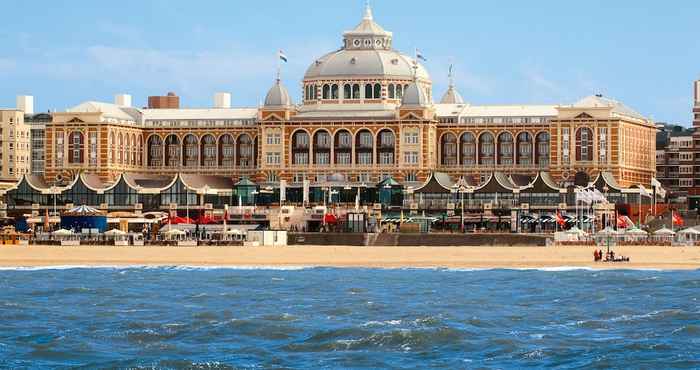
[0,267,700,369]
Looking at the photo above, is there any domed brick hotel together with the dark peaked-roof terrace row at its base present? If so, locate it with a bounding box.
[0,7,656,227]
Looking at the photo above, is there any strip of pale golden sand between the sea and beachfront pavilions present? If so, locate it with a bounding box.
[0,246,700,270]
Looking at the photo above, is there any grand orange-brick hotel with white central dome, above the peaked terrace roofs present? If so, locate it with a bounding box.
[0,8,656,218]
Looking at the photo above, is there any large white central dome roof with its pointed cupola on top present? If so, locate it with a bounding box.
[304,6,430,83]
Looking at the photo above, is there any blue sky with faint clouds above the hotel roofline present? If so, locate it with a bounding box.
[0,0,700,125]
